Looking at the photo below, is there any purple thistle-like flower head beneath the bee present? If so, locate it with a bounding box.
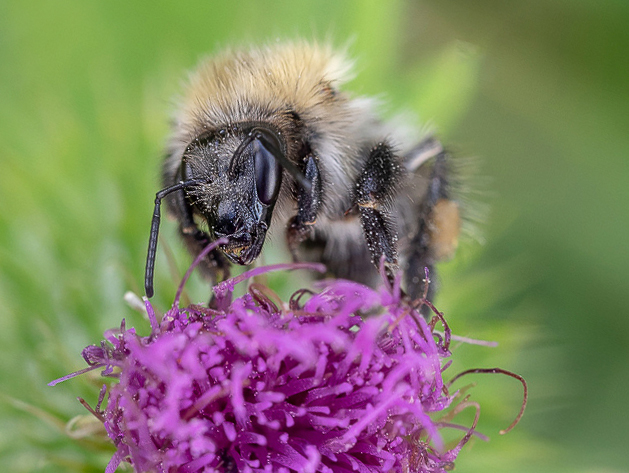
[51,242,524,473]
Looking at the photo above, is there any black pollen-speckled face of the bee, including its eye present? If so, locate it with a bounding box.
[181,124,285,265]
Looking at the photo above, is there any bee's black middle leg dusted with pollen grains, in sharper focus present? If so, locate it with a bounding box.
[354,142,402,279]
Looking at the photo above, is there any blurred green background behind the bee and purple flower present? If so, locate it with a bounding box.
[0,0,629,472]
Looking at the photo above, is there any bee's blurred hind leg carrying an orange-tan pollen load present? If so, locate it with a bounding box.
[404,145,460,317]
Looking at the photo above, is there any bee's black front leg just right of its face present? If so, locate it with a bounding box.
[286,154,321,261]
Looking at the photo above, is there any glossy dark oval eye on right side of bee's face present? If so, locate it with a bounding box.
[251,135,282,205]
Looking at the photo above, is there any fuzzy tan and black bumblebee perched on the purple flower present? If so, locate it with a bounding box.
[145,42,460,306]
